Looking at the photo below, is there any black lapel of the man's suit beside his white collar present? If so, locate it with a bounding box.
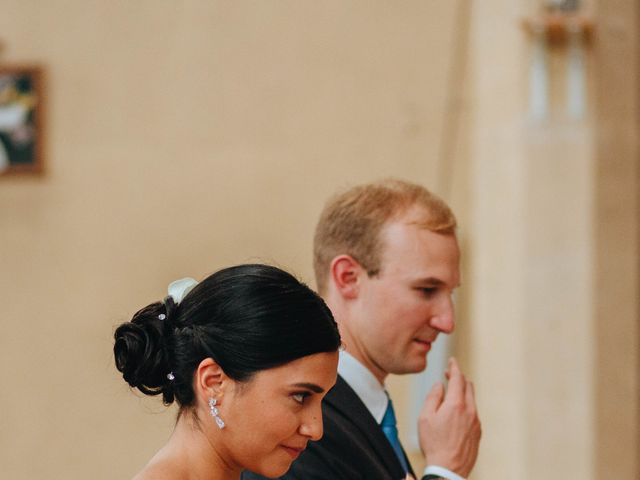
[324,375,411,478]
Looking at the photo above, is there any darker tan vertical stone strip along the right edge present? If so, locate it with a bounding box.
[593,0,640,480]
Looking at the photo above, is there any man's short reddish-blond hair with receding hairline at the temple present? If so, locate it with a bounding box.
[313,179,456,293]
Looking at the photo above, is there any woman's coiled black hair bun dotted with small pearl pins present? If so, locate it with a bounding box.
[113,303,173,404]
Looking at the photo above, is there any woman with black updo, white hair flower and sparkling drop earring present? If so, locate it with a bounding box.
[113,265,340,480]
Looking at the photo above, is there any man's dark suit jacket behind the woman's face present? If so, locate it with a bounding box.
[242,376,438,480]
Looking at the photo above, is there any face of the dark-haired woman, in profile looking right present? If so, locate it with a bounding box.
[219,352,338,477]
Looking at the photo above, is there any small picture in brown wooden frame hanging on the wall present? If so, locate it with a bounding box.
[0,65,44,175]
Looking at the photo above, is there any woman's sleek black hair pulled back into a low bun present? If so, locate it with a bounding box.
[113,264,340,407]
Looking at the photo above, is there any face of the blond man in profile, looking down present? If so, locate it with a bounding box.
[346,211,460,380]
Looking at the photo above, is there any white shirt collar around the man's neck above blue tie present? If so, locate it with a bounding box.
[338,350,389,423]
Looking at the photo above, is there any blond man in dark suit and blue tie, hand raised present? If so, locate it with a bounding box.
[242,180,480,480]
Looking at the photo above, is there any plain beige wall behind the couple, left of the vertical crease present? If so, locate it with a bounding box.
[0,0,455,480]
